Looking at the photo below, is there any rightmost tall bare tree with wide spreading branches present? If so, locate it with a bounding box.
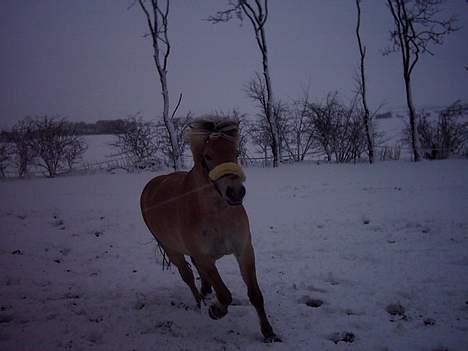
[384,0,457,161]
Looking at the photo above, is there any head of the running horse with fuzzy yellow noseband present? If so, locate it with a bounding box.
[192,119,245,206]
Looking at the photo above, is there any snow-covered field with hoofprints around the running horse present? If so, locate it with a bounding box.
[0,160,468,351]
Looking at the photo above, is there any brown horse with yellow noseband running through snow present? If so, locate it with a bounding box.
[137,118,281,342]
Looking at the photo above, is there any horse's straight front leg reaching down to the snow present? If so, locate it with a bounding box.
[236,243,281,342]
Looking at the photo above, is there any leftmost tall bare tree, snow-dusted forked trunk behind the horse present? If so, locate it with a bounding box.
[138,0,182,170]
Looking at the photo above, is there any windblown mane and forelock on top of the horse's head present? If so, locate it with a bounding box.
[187,116,239,161]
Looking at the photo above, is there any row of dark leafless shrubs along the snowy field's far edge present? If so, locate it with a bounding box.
[0,101,468,177]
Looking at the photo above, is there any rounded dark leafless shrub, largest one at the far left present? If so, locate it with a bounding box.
[30,116,87,177]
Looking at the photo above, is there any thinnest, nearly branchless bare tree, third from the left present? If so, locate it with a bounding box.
[356,0,374,163]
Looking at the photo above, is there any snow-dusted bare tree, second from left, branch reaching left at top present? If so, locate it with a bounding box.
[208,0,280,167]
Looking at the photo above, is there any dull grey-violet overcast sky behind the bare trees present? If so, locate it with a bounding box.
[0,0,468,127]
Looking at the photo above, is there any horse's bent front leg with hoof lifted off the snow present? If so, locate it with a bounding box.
[193,257,232,319]
